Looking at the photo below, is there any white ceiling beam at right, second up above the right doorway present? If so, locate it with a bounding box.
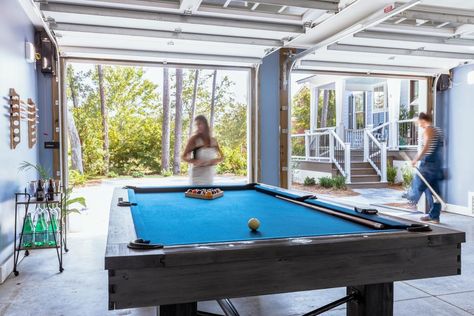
[328,44,474,60]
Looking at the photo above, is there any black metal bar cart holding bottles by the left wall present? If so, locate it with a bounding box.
[13,192,69,276]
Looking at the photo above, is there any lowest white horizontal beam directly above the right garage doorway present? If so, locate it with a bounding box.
[298,60,449,75]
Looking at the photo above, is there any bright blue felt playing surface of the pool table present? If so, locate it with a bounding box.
[129,190,398,246]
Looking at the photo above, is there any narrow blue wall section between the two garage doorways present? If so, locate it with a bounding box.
[258,51,280,185]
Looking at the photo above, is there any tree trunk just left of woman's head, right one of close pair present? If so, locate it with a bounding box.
[173,68,183,174]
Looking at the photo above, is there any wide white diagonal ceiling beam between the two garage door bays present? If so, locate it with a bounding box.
[289,0,421,60]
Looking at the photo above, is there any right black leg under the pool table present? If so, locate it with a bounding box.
[347,282,393,316]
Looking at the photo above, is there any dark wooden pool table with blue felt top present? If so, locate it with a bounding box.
[105,184,465,316]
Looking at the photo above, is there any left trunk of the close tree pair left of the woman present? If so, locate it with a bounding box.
[161,68,170,171]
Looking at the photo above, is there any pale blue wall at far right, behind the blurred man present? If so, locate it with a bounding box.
[437,65,474,206]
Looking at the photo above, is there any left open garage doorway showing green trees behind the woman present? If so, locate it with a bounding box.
[64,61,254,186]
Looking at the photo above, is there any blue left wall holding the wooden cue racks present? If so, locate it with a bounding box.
[0,1,44,265]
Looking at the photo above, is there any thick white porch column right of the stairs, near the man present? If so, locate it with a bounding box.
[387,79,402,148]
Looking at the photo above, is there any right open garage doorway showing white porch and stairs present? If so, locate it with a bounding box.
[291,73,431,196]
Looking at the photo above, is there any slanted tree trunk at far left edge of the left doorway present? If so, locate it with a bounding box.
[67,66,84,174]
